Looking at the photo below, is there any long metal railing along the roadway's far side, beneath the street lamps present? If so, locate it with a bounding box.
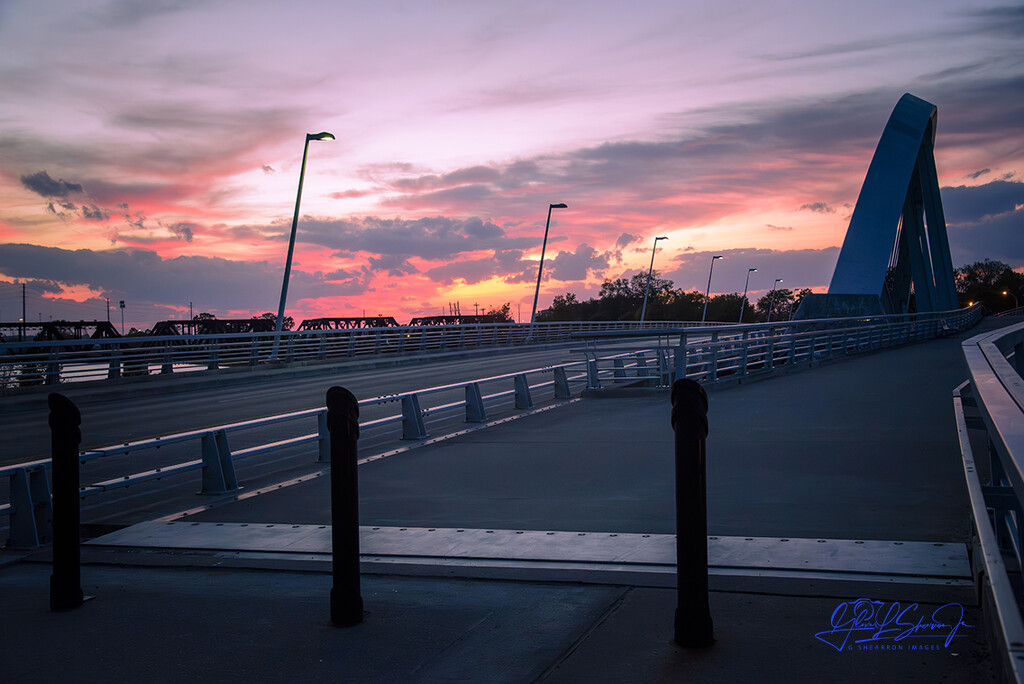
[0,322,726,393]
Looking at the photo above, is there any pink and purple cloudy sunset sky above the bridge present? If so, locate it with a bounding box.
[0,0,1024,328]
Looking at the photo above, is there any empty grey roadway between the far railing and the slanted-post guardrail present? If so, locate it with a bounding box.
[0,344,598,465]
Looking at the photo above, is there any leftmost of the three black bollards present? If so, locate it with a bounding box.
[47,392,83,610]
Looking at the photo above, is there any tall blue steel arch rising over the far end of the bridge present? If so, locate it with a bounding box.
[799,93,957,317]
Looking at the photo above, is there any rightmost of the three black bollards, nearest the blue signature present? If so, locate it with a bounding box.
[672,379,715,647]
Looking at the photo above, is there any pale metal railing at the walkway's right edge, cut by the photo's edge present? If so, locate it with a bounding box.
[953,324,1024,682]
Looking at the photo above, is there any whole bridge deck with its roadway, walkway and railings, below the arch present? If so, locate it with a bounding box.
[0,93,1024,682]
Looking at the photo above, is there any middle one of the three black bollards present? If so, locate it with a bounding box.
[327,387,362,627]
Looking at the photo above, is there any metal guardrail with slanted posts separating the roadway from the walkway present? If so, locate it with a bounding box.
[0,306,980,547]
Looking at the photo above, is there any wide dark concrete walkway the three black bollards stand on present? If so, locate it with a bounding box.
[0,319,1007,682]
